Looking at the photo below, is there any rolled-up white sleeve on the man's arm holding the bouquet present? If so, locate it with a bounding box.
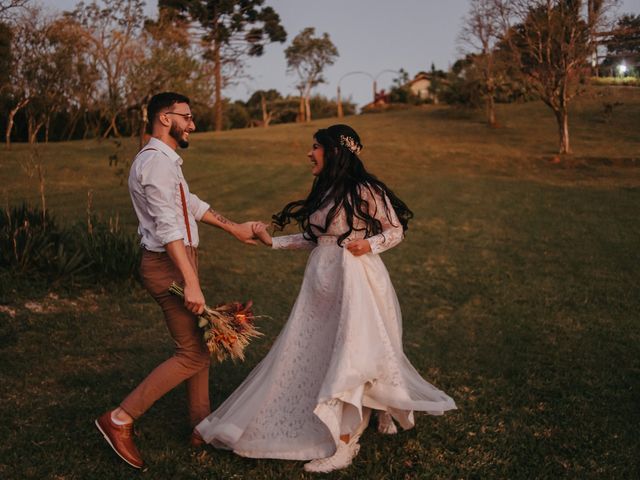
[139,157,184,245]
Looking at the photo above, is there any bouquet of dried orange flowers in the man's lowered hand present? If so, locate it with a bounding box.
[169,282,262,362]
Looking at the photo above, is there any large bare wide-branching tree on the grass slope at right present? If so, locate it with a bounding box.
[503,0,606,154]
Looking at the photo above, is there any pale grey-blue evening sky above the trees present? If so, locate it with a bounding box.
[42,0,640,106]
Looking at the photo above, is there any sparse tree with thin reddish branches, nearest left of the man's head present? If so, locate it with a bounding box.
[70,0,144,138]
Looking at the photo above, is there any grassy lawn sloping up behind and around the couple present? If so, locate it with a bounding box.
[0,87,640,480]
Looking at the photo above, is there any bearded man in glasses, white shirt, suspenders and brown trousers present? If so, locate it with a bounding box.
[96,92,255,468]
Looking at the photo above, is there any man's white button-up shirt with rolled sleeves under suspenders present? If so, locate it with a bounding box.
[129,137,209,252]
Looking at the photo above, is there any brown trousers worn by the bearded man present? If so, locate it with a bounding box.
[120,247,211,426]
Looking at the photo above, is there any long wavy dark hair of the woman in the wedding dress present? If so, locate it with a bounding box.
[272,125,413,245]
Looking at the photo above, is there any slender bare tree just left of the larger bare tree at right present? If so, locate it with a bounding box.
[459,0,504,126]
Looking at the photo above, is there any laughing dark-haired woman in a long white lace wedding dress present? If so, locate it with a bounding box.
[196,125,456,472]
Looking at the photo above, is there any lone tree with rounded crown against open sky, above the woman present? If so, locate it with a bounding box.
[284,27,338,122]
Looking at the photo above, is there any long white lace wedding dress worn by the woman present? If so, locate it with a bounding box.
[196,189,456,460]
